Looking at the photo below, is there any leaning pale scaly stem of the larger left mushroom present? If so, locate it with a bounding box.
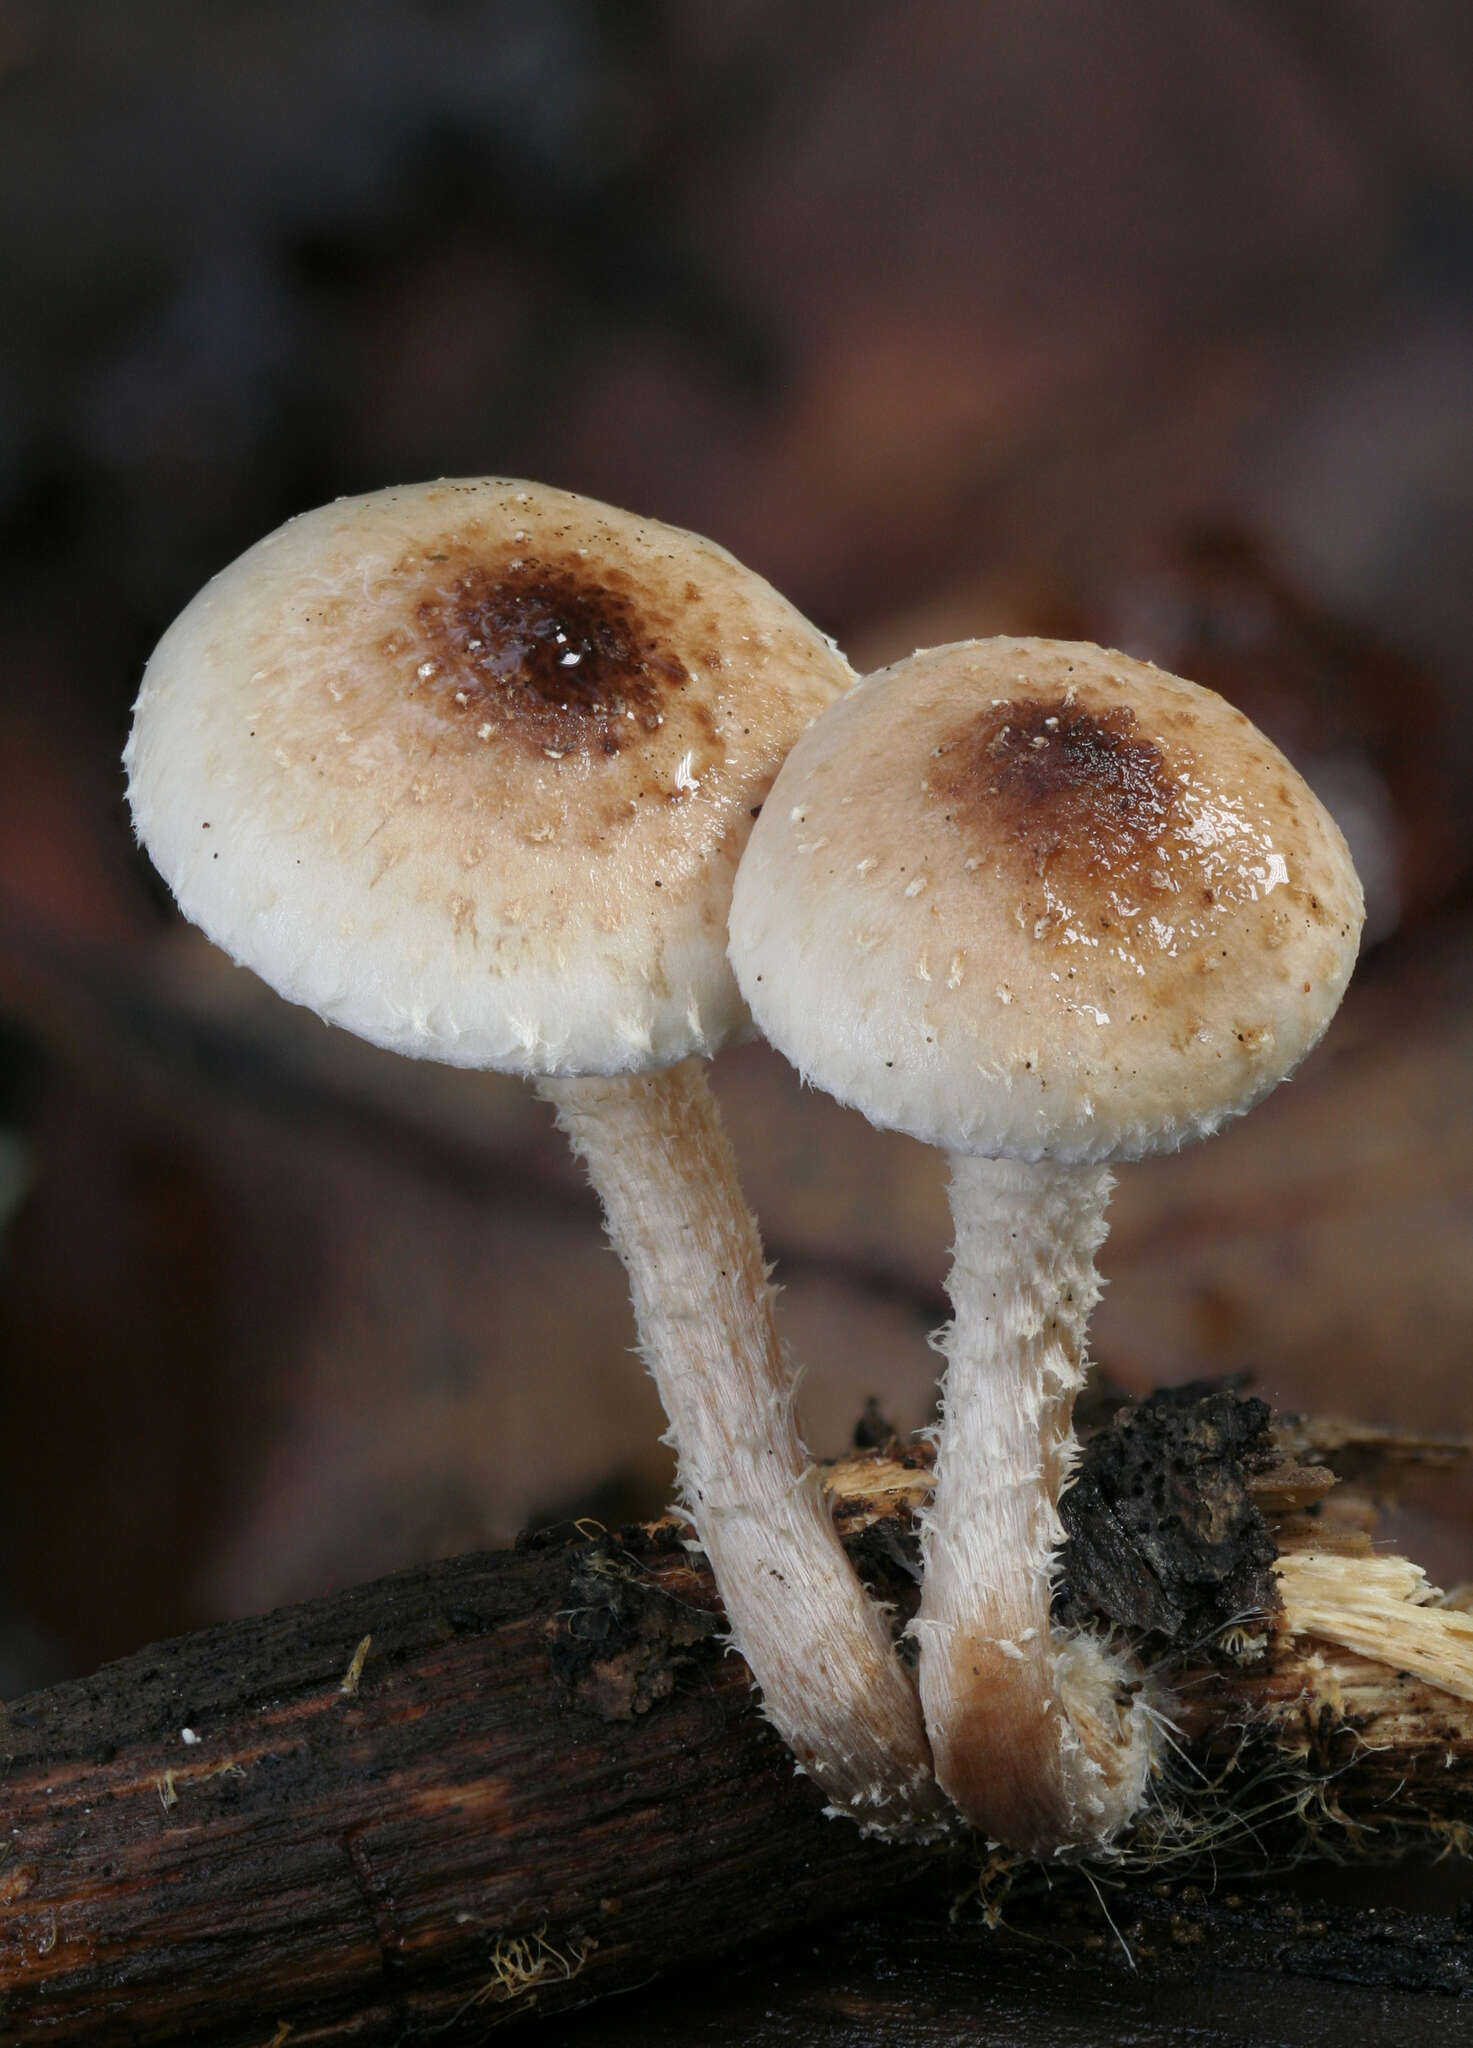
[539,1059,946,1839]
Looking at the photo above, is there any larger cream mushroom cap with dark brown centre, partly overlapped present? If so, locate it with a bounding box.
[125,477,854,1075]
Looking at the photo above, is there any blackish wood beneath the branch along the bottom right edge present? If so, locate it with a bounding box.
[537,1886,1473,2048]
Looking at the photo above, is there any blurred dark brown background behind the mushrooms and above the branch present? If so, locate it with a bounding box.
[0,0,1473,1694]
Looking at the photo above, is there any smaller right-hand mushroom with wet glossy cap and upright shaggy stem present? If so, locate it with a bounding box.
[729,639,1362,1855]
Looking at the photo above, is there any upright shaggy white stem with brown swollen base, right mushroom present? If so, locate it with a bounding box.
[914,1153,1151,1855]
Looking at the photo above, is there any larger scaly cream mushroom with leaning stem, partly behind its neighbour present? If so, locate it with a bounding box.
[125,477,944,1833]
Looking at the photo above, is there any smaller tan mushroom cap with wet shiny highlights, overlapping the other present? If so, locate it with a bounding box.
[731,639,1362,1165]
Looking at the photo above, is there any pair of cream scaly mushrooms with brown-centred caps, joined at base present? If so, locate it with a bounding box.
[127,479,1360,1855]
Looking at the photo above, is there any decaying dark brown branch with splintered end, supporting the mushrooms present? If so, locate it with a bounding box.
[0,1389,1473,2048]
